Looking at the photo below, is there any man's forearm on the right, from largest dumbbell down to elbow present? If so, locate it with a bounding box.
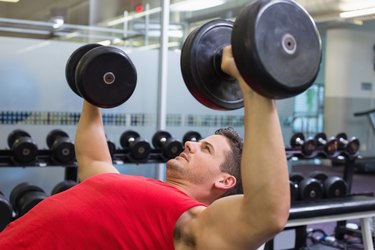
[241,87,290,227]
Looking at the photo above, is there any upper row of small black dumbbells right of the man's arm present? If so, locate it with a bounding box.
[287,132,360,158]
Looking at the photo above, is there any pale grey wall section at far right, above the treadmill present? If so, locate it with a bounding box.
[324,29,375,155]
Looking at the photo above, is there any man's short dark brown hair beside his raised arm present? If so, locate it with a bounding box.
[215,127,243,197]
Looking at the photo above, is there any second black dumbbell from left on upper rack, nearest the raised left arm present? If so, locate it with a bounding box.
[46,129,75,164]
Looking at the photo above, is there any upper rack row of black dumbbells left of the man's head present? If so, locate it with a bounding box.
[0,129,206,165]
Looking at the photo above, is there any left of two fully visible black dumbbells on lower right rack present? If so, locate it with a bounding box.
[289,174,323,201]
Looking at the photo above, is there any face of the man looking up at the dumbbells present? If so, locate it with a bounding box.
[167,135,230,184]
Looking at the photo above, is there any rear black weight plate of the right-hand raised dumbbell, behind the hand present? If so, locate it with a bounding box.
[181,19,243,110]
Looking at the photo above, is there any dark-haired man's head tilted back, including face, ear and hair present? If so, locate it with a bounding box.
[167,128,242,203]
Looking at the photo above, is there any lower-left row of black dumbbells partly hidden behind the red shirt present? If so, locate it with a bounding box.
[0,180,77,231]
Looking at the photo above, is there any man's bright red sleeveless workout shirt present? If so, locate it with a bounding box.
[0,174,204,250]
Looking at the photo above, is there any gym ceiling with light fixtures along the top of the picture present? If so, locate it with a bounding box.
[0,0,375,45]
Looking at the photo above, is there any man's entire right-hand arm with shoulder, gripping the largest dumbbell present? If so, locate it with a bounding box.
[188,48,290,250]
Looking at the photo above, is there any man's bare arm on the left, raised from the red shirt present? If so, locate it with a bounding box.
[75,101,118,181]
